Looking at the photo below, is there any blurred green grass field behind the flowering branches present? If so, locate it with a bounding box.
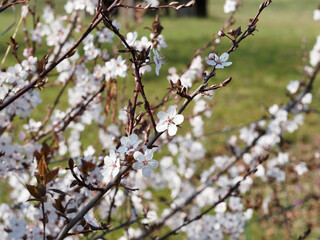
[0,0,320,239]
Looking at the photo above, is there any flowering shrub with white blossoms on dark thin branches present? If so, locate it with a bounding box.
[0,0,320,239]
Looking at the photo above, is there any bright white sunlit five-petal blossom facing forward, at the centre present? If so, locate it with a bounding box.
[156,106,184,136]
